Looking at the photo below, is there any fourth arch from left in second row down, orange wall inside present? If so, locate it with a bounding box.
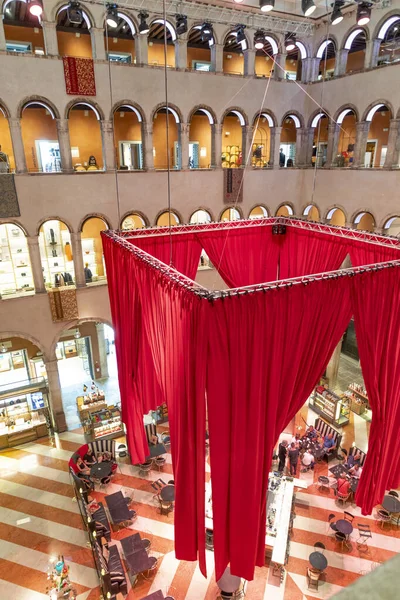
[114,104,144,171]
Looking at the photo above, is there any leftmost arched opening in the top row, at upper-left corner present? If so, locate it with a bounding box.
[3,0,46,55]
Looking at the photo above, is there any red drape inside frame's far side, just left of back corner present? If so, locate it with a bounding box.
[197,226,281,288]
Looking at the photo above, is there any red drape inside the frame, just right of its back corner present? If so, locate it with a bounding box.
[279,227,348,279]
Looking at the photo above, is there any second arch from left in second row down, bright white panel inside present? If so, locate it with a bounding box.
[21,101,61,173]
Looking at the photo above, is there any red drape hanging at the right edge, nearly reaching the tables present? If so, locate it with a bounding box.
[352,268,400,515]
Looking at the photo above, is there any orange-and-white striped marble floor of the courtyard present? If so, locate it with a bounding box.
[0,408,400,600]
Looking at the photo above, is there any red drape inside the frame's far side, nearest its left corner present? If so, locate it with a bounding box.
[127,234,201,279]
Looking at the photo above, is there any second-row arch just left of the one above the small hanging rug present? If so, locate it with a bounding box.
[189,108,215,169]
